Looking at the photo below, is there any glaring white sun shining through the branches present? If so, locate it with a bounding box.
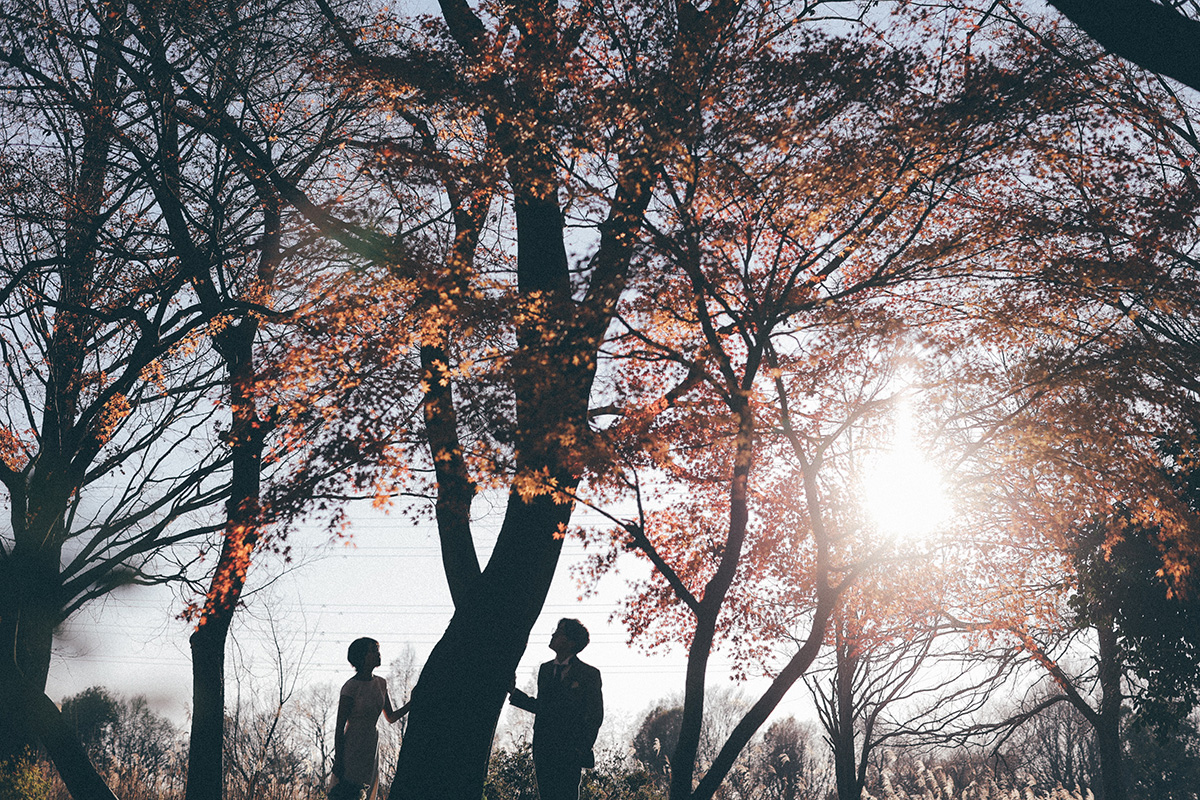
[863,405,950,540]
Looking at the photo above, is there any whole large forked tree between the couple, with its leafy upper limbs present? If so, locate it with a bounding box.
[292,1,736,798]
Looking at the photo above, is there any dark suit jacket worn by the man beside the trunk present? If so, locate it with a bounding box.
[512,657,604,766]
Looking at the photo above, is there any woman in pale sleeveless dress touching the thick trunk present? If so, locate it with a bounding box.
[329,637,408,800]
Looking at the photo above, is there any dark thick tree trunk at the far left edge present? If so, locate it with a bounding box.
[0,0,125,767]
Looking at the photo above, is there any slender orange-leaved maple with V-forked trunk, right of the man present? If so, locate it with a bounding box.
[576,9,1128,798]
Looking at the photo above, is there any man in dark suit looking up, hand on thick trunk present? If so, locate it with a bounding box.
[510,619,604,800]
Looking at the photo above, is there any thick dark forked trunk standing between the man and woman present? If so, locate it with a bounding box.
[390,0,653,800]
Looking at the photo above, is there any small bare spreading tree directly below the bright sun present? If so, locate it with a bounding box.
[804,525,1055,800]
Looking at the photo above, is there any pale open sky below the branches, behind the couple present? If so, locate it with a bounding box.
[47,504,814,734]
